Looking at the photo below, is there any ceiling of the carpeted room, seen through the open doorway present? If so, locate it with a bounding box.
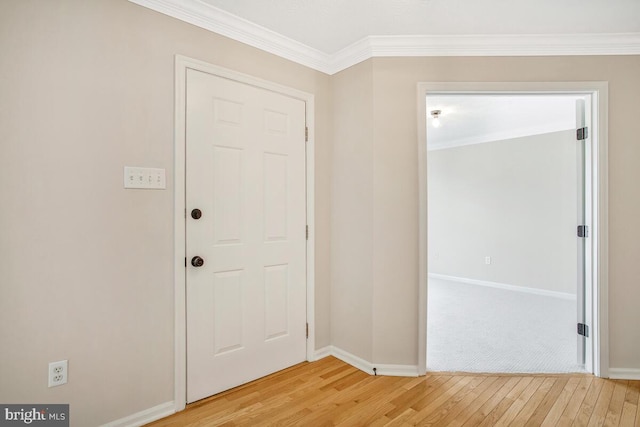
[427,94,583,151]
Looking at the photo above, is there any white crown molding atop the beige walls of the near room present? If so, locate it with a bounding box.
[129,0,640,74]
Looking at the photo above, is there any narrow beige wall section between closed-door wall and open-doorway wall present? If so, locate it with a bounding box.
[331,62,374,361]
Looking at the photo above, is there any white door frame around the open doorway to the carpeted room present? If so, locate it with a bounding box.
[417,82,609,378]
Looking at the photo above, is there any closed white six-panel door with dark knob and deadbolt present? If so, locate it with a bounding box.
[186,70,306,402]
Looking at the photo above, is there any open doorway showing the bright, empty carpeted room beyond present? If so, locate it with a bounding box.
[419,83,606,375]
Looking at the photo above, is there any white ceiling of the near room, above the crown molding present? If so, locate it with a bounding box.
[202,0,640,54]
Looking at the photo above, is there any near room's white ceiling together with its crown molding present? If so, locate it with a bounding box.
[129,0,640,74]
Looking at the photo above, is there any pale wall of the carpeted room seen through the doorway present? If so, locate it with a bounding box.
[428,130,579,294]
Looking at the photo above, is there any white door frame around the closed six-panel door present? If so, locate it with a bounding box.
[173,55,315,412]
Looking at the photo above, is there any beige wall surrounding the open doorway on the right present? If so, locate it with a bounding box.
[362,56,640,369]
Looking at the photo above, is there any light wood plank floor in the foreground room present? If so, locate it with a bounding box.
[149,357,640,427]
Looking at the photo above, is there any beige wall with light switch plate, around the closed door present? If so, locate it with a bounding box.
[0,0,332,426]
